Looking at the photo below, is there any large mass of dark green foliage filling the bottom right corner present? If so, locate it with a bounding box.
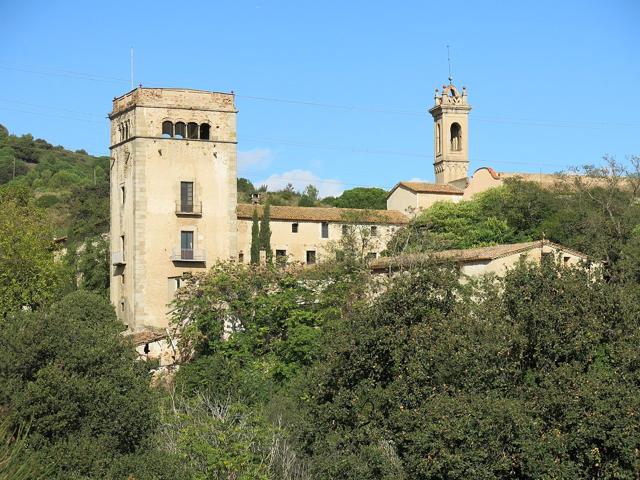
[300,263,640,479]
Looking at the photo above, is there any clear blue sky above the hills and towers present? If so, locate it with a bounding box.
[0,0,640,195]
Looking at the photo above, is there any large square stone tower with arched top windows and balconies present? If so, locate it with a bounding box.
[109,87,237,332]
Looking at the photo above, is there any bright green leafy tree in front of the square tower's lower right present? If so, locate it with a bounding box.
[175,263,333,402]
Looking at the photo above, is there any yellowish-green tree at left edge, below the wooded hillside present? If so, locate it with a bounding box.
[0,186,68,319]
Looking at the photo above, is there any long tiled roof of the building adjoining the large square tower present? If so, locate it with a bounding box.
[236,203,409,225]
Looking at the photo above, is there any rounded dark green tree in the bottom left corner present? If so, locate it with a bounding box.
[0,292,156,479]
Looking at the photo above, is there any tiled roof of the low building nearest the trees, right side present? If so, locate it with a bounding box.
[370,240,587,270]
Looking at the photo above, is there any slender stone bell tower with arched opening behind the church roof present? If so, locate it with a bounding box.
[429,83,471,188]
